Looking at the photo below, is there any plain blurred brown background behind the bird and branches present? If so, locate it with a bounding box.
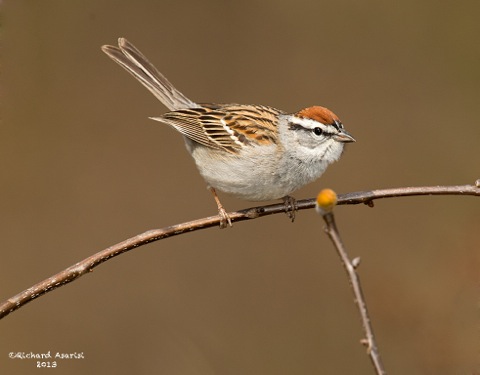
[0,0,480,375]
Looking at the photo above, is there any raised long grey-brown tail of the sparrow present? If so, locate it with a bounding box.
[102,38,199,111]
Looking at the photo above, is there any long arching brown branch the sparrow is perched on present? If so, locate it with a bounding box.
[0,180,480,319]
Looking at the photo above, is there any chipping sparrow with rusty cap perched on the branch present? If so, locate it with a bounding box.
[102,38,355,227]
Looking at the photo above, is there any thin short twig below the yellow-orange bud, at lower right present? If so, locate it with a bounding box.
[323,212,385,375]
